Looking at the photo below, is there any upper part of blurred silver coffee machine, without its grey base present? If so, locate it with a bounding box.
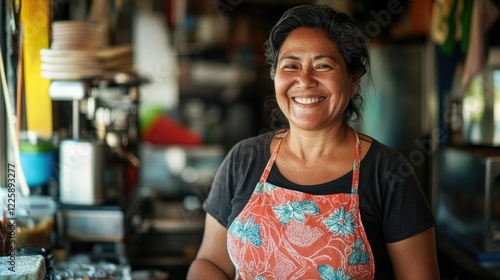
[50,74,139,205]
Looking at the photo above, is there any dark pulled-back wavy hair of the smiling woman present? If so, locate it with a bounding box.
[264,4,370,128]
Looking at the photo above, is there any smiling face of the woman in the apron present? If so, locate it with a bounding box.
[274,27,356,131]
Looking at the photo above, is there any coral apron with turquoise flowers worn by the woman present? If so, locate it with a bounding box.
[227,133,375,280]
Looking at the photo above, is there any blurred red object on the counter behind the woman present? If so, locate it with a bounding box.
[143,116,203,145]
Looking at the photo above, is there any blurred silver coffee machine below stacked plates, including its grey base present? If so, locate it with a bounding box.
[49,73,142,244]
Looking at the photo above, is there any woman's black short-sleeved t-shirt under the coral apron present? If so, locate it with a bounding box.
[204,132,435,279]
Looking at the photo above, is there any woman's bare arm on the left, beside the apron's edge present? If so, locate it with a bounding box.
[187,214,235,280]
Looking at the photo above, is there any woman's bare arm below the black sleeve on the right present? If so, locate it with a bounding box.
[387,228,439,280]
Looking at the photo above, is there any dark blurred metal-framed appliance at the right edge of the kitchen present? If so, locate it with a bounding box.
[436,146,500,259]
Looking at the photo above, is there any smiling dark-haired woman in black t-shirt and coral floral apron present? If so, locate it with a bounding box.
[188,5,439,279]
